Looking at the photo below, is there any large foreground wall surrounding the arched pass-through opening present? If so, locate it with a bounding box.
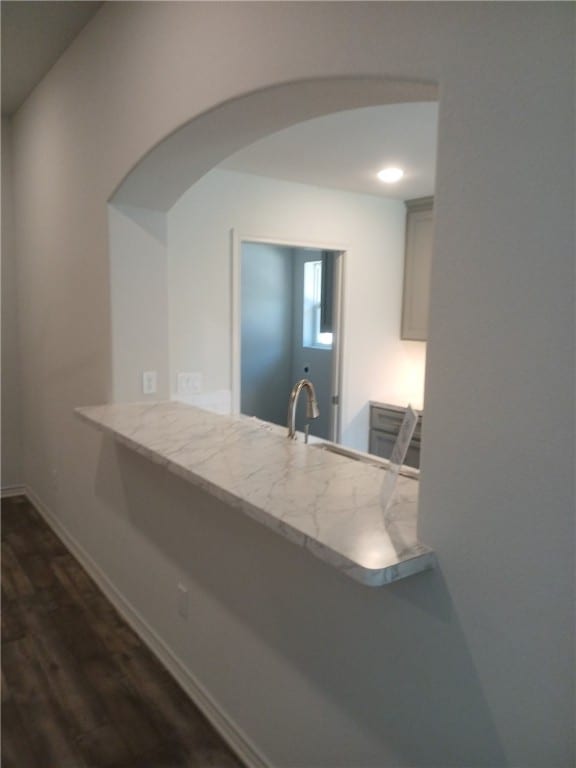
[7,2,576,768]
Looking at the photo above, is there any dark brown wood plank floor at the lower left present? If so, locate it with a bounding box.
[2,496,242,768]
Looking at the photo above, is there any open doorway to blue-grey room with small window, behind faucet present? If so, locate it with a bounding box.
[233,238,343,441]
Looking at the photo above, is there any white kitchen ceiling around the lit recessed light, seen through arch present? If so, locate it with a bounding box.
[220,102,438,200]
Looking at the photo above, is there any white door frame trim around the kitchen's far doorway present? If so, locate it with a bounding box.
[230,228,350,443]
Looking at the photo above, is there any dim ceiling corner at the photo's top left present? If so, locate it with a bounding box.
[0,0,103,115]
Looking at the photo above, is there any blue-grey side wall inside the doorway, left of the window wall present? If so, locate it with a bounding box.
[240,243,293,424]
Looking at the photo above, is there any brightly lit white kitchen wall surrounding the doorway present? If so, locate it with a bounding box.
[168,165,425,450]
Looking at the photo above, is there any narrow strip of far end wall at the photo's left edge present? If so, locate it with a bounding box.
[0,117,22,490]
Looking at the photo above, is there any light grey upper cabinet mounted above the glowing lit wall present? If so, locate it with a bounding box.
[401,197,434,341]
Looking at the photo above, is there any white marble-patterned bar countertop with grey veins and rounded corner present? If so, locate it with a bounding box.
[76,401,435,586]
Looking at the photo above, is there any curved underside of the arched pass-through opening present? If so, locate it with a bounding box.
[110,77,438,211]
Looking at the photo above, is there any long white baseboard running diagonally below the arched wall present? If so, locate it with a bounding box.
[23,487,271,768]
